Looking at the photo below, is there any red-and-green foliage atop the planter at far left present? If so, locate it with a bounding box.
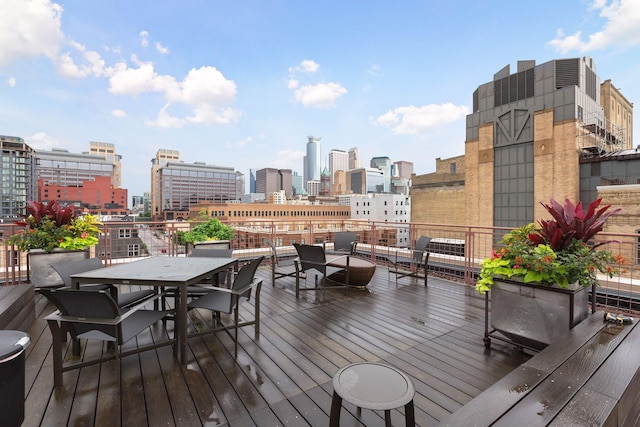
[8,200,102,252]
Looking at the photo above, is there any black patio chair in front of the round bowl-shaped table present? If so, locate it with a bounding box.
[293,243,349,298]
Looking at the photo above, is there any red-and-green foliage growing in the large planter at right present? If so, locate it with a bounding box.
[476,199,624,294]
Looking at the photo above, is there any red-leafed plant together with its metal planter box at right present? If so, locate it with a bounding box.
[476,199,624,350]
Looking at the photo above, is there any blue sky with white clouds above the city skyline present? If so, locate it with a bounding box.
[0,0,640,195]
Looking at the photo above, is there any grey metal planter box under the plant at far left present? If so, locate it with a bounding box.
[27,249,89,288]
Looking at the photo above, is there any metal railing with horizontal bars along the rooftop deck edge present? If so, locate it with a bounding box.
[0,219,640,312]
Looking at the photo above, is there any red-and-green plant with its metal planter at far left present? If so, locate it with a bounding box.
[7,200,102,287]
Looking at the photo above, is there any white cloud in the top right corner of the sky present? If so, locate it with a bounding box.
[549,0,640,54]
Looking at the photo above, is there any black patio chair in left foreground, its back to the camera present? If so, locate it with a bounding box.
[41,288,172,386]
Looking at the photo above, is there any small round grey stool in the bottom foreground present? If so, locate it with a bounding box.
[329,362,416,427]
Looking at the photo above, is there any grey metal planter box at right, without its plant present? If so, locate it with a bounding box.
[490,279,589,350]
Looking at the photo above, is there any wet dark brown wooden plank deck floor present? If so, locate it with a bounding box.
[23,266,528,427]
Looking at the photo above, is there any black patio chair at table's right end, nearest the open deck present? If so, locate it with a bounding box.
[188,256,264,357]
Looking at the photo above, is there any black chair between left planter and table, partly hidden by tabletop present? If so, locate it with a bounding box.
[51,258,158,309]
